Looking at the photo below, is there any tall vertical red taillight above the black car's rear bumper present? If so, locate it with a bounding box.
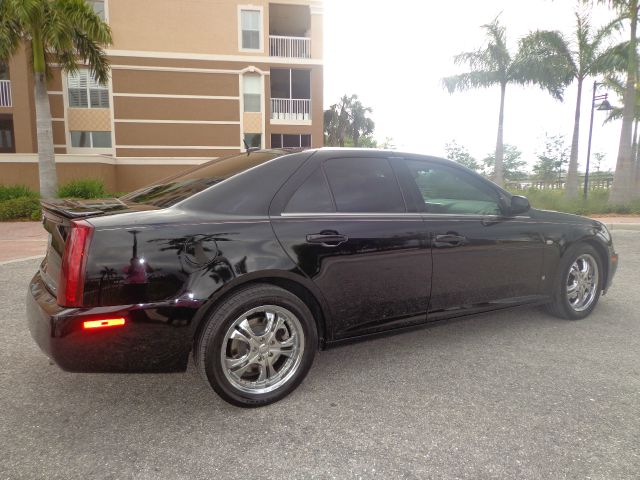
[58,221,93,307]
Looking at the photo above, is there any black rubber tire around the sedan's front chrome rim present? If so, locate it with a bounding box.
[545,243,604,320]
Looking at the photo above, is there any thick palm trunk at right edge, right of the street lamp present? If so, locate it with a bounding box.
[609,0,638,205]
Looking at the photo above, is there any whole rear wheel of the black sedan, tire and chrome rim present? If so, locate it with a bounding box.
[194,285,317,407]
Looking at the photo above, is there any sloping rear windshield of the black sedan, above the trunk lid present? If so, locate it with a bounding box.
[121,150,280,207]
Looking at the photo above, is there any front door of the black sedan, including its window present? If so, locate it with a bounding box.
[401,157,544,320]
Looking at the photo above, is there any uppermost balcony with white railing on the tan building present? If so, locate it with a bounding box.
[269,3,311,58]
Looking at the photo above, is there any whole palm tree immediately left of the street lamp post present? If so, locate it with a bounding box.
[522,13,619,197]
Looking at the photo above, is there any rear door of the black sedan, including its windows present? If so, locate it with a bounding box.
[271,152,431,339]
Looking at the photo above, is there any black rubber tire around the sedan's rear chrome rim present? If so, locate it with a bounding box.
[194,284,318,408]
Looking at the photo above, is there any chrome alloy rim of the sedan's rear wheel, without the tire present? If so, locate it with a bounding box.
[220,305,304,394]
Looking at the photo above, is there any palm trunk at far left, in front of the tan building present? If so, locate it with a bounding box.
[31,31,58,198]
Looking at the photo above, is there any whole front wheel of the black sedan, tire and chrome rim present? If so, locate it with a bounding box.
[547,245,603,320]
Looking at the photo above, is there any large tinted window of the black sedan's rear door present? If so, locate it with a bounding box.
[324,158,405,213]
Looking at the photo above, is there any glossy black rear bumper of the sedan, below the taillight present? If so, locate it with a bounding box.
[26,273,197,373]
